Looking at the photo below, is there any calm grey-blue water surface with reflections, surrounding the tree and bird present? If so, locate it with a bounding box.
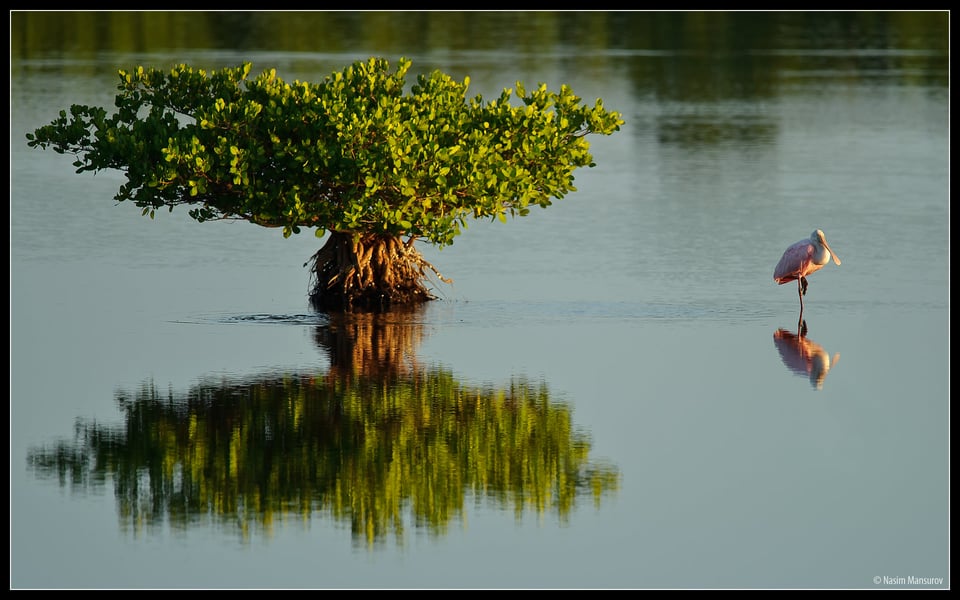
[10,13,950,589]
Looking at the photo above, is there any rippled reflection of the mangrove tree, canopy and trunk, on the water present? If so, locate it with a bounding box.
[28,310,620,546]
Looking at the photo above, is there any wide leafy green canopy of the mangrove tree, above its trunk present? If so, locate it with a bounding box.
[27,58,623,246]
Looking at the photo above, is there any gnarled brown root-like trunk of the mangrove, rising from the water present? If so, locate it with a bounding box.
[304,232,451,310]
